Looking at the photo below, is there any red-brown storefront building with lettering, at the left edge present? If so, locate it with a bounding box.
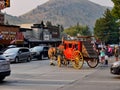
[0,25,24,47]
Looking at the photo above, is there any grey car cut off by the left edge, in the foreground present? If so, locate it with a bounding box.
[0,55,11,81]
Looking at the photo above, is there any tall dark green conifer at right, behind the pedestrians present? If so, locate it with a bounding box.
[94,9,119,43]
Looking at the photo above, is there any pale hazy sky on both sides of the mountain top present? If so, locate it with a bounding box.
[2,0,113,16]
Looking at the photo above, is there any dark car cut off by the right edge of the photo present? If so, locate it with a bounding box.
[110,61,120,75]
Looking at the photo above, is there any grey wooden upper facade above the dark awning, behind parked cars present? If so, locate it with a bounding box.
[31,22,61,40]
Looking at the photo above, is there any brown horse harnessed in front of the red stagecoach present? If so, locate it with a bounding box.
[48,47,56,65]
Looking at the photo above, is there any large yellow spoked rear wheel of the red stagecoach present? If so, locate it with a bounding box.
[72,51,84,69]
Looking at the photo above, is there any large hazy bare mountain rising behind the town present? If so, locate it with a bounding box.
[5,0,107,28]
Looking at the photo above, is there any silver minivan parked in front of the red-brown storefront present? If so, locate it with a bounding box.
[3,47,31,63]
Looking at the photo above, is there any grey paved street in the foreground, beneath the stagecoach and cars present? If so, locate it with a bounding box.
[0,60,120,90]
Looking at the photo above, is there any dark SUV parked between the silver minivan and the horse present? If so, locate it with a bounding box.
[30,46,49,60]
